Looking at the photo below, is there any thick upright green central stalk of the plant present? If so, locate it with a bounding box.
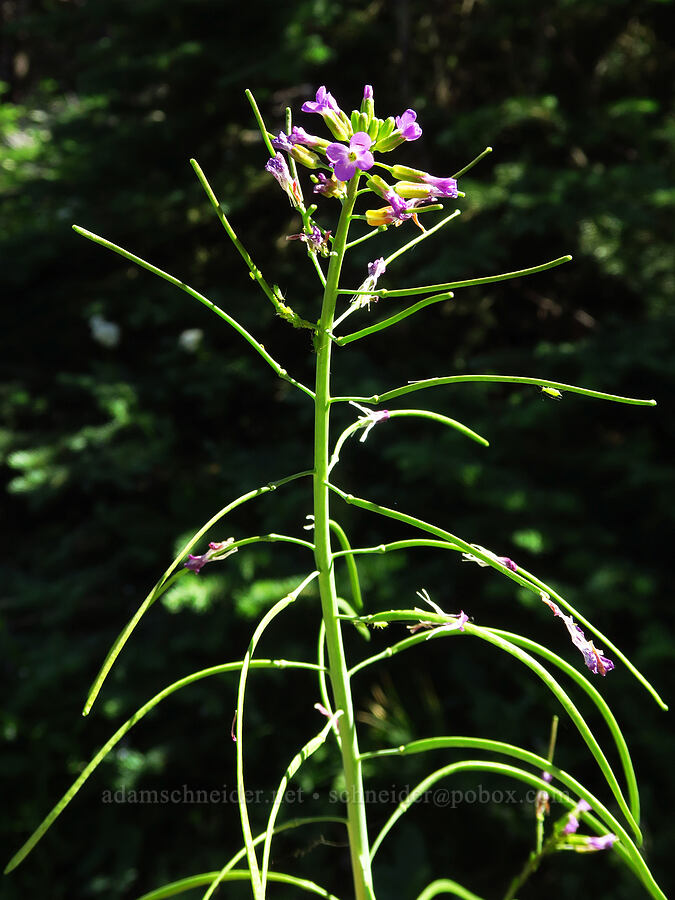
[314,174,374,900]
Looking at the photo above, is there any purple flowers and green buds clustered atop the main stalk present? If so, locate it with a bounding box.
[265,84,458,232]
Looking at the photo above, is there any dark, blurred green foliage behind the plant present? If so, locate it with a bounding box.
[0,0,675,900]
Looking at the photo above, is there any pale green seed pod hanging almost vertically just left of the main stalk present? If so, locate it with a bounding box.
[235,572,319,900]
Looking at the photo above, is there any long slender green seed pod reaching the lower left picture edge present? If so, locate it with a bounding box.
[5,659,328,874]
